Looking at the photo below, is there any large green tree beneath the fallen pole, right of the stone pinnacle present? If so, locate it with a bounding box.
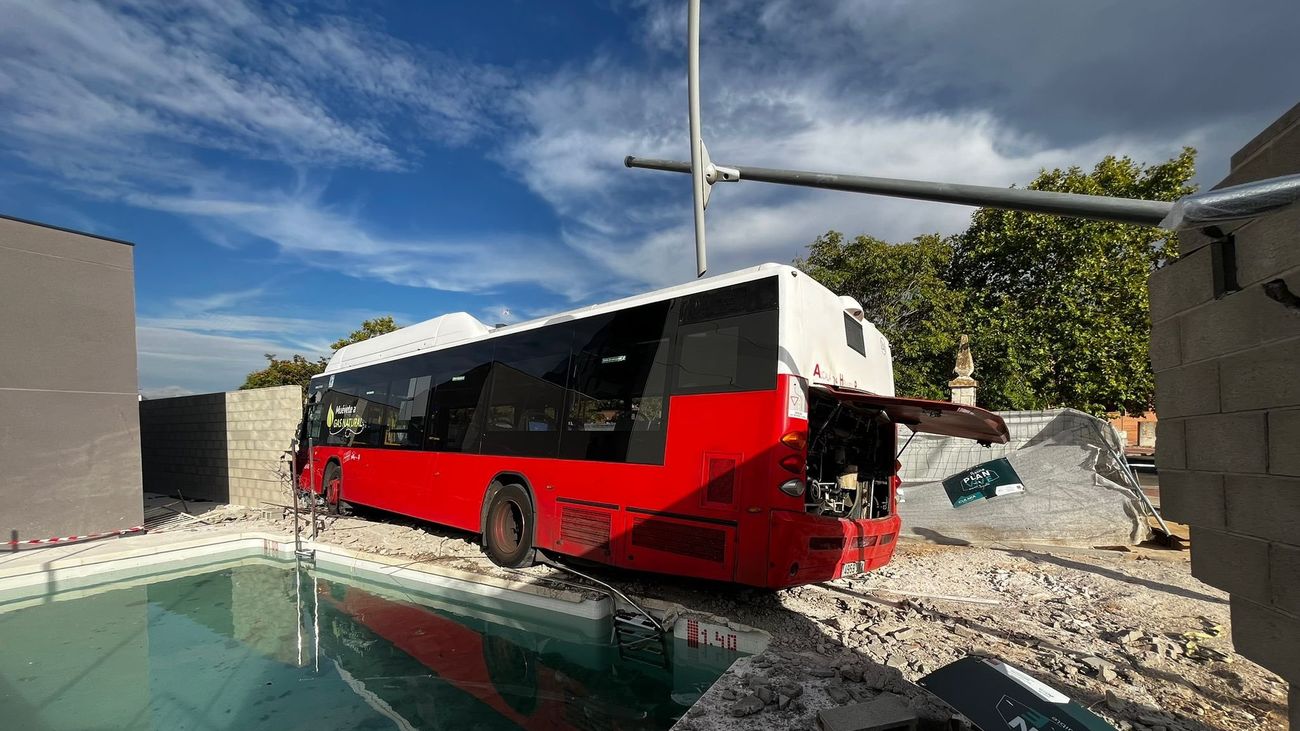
[949,148,1196,415]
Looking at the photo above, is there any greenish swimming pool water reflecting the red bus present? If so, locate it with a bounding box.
[0,558,737,731]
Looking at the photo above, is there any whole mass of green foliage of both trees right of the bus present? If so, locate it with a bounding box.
[796,148,1195,414]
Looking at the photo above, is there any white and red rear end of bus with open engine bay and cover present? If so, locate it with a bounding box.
[767,274,1009,587]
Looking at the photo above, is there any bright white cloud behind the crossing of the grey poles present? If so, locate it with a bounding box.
[506,61,1196,285]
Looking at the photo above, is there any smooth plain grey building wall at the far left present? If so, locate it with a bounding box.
[0,217,143,541]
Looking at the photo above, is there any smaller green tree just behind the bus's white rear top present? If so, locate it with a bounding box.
[794,232,963,398]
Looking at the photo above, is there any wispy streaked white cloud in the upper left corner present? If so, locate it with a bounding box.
[0,0,507,176]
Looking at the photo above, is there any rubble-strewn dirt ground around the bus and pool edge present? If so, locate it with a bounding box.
[186,499,1287,731]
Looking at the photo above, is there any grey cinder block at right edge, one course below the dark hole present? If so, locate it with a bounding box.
[1216,338,1300,411]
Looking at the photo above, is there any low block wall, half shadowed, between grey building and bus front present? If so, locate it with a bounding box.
[140,386,303,507]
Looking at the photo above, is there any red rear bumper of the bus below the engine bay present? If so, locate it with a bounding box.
[767,510,902,589]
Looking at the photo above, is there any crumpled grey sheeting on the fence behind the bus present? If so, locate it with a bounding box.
[898,408,1152,546]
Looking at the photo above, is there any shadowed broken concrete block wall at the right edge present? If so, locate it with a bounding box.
[1149,104,1300,697]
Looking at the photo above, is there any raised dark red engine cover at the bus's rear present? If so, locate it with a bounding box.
[811,384,1011,445]
